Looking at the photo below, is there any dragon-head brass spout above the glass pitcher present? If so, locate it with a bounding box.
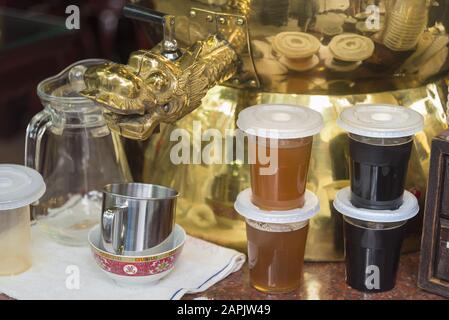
[81,36,237,140]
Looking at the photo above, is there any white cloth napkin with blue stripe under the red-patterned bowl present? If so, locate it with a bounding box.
[0,227,245,300]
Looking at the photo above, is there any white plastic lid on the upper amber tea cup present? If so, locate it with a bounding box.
[237,104,323,139]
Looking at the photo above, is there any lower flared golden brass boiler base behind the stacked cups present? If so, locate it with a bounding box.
[141,81,447,261]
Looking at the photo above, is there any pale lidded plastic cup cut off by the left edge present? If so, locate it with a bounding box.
[0,164,45,276]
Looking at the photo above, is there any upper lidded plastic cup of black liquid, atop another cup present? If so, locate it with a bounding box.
[337,105,424,210]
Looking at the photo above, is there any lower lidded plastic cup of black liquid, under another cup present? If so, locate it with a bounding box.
[334,187,419,293]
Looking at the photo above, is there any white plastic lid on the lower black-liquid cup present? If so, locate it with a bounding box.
[334,187,419,222]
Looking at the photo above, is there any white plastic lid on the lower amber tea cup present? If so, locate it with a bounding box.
[234,188,320,224]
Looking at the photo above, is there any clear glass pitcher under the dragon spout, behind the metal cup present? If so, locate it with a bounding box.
[25,59,131,245]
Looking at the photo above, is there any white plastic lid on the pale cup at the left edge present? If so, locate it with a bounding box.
[0,164,45,210]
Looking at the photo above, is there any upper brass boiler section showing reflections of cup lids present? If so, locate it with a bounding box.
[144,0,449,95]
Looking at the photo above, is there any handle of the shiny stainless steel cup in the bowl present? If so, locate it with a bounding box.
[101,207,127,254]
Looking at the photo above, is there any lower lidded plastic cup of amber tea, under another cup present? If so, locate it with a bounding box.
[234,189,320,293]
